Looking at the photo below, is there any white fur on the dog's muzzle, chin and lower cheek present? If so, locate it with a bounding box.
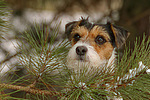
[67,41,115,70]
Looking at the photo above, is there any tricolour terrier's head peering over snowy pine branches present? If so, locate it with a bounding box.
[65,18,129,69]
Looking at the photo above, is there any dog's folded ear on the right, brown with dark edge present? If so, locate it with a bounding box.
[107,23,130,48]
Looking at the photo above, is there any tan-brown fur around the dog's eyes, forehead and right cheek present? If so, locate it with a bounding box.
[71,25,114,60]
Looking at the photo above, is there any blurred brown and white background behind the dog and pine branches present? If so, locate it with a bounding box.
[0,0,150,73]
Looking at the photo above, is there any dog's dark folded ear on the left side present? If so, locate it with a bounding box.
[65,21,78,40]
